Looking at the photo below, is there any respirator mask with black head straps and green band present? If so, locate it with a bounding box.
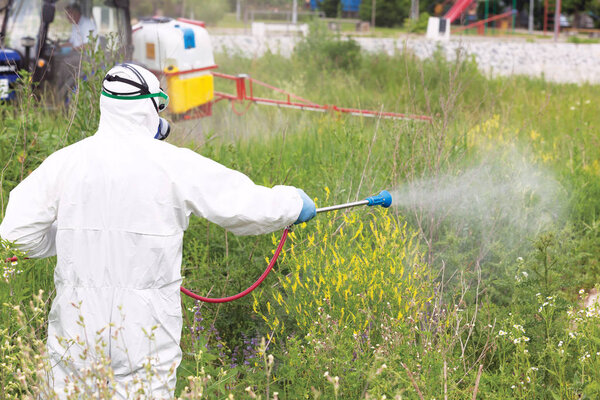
[101,64,171,140]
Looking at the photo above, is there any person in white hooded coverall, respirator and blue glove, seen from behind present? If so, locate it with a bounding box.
[0,64,315,399]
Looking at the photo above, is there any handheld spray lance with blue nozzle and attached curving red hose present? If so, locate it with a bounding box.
[180,190,392,303]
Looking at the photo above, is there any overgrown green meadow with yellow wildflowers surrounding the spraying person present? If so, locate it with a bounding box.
[0,28,600,399]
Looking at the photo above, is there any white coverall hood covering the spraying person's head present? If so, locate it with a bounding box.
[97,64,160,139]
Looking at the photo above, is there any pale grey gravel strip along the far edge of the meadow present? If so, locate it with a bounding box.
[211,35,600,83]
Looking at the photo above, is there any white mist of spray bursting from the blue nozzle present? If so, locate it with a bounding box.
[390,148,567,254]
